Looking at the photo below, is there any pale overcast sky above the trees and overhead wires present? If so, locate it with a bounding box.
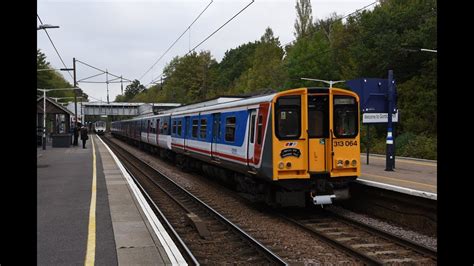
[37,0,374,101]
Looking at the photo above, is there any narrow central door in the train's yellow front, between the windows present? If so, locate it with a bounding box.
[308,94,330,173]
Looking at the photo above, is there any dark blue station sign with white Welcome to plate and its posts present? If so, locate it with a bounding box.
[347,70,399,171]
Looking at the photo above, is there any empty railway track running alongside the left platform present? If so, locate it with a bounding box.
[103,138,286,265]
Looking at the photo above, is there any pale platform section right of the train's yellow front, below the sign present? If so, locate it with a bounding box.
[358,153,437,200]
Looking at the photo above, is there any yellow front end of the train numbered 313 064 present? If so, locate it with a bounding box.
[271,88,360,206]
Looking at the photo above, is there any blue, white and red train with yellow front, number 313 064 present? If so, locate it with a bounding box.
[111,87,361,207]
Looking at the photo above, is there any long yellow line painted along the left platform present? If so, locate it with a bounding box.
[84,136,97,265]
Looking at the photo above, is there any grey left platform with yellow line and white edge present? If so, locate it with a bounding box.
[37,134,185,265]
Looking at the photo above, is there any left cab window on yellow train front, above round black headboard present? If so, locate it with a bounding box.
[275,96,301,139]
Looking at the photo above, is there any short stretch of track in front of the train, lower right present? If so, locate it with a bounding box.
[278,210,437,265]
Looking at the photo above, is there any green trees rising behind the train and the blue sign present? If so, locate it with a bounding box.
[123,0,437,158]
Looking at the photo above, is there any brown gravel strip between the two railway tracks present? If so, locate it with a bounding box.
[107,138,360,265]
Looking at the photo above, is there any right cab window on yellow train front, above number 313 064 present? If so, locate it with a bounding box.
[334,96,359,138]
